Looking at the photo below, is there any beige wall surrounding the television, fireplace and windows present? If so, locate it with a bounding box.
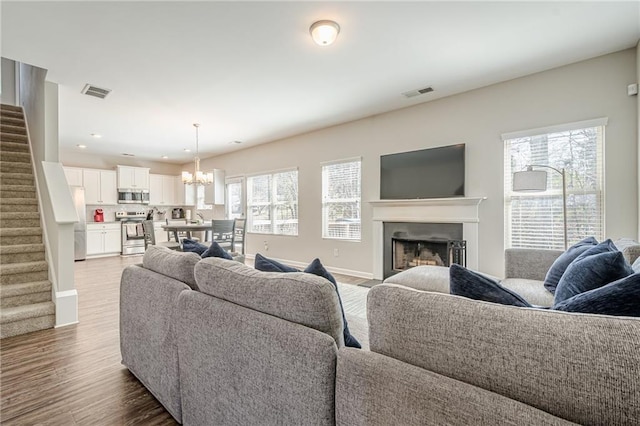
[202,49,639,276]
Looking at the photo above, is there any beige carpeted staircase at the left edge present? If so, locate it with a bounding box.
[0,105,55,338]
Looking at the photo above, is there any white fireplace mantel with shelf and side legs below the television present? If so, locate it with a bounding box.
[369,197,487,280]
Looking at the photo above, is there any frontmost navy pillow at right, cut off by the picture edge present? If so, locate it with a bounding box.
[553,273,640,317]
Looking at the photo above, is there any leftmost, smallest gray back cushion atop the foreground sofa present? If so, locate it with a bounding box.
[142,245,200,290]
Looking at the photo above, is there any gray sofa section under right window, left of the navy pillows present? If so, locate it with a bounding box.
[504,249,563,281]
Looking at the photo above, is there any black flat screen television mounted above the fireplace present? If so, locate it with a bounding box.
[380,144,465,200]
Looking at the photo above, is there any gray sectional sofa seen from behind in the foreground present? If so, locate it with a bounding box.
[120,248,640,425]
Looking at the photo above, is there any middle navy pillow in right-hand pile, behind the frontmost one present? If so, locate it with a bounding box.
[553,251,633,306]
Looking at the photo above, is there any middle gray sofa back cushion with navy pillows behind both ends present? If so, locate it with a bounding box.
[195,258,344,347]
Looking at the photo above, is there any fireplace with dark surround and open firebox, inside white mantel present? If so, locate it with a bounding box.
[383,222,466,278]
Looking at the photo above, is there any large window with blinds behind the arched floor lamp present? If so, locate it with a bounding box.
[503,119,606,250]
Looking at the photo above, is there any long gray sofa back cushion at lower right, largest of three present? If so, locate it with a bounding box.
[367,284,640,425]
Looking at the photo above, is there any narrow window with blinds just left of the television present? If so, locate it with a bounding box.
[322,159,362,240]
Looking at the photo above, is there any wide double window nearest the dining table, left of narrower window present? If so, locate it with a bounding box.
[247,170,298,235]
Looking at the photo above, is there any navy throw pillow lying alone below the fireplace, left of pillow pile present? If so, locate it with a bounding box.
[449,263,531,308]
